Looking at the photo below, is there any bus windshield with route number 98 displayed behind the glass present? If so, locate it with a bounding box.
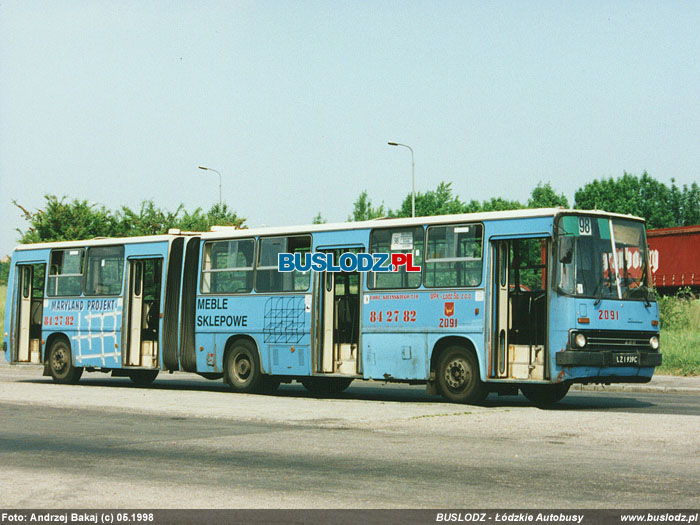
[556,215,650,301]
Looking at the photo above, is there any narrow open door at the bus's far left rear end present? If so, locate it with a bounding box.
[15,264,45,363]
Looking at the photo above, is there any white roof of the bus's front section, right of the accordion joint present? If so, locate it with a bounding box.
[201,208,644,240]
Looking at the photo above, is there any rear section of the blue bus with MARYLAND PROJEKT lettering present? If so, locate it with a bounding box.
[3,235,184,384]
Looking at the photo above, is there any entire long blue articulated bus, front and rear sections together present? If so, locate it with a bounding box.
[3,209,661,404]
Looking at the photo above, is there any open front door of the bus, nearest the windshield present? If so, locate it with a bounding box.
[489,238,549,381]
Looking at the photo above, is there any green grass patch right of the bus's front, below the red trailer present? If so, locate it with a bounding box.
[656,293,700,376]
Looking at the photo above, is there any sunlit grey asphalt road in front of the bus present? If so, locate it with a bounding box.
[0,368,700,508]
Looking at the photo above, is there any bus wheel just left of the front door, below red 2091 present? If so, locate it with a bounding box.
[438,346,488,404]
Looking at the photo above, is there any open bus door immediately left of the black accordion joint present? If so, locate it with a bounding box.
[124,258,163,368]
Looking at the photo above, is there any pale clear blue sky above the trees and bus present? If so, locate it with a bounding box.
[0,0,700,255]
